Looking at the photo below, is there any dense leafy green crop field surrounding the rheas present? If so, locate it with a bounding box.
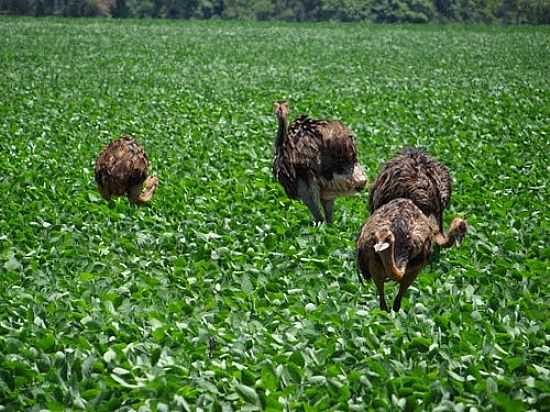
[0,18,550,411]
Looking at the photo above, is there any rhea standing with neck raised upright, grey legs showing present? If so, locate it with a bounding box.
[273,101,367,223]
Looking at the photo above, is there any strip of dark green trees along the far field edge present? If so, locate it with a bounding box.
[0,0,550,24]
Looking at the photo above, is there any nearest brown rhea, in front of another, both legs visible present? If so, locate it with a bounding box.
[357,199,467,312]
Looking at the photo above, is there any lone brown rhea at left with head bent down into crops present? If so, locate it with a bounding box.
[95,136,158,205]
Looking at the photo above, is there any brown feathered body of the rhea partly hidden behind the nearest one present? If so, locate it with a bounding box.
[369,148,452,231]
